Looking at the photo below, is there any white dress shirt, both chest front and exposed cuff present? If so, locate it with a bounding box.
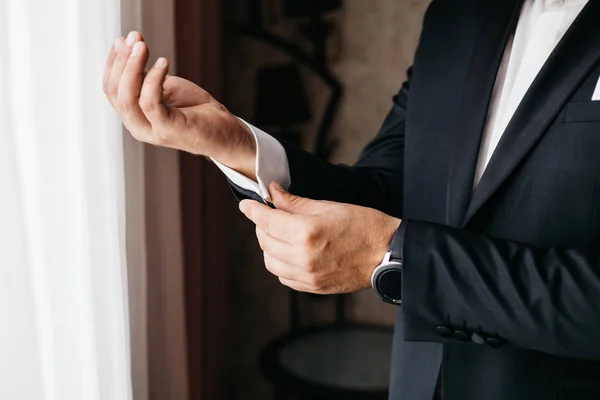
[215,0,600,199]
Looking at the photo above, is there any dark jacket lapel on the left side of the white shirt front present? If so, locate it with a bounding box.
[446,0,523,227]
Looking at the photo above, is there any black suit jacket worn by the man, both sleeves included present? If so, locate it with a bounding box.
[231,0,600,400]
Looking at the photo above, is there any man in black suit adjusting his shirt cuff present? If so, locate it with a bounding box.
[105,0,600,400]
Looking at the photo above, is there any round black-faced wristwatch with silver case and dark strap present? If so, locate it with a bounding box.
[371,221,406,306]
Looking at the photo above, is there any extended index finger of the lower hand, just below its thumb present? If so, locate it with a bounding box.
[240,200,305,243]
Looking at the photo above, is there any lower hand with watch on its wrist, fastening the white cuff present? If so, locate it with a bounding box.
[240,183,401,294]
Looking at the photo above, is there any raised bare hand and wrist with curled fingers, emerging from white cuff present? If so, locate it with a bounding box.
[103,32,256,180]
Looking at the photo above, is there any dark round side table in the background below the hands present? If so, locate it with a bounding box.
[260,324,393,400]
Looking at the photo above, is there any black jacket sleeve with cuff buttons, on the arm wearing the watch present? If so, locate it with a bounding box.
[403,221,600,360]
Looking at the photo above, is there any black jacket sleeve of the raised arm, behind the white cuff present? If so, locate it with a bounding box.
[230,70,410,217]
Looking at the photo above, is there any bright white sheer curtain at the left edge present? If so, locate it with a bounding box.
[0,0,132,400]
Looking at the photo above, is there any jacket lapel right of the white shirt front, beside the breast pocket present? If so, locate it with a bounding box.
[461,0,600,227]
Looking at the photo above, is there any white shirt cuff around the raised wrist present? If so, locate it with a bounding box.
[213,118,291,200]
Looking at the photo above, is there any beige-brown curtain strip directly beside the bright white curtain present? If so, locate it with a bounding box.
[121,0,189,400]
